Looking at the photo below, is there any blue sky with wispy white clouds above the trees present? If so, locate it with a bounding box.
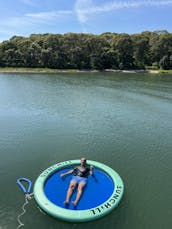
[0,0,172,42]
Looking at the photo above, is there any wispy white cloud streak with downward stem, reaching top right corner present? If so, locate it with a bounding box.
[75,0,172,24]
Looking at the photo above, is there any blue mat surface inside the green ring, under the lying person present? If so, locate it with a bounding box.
[44,169,115,210]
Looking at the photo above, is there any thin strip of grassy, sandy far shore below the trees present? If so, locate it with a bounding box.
[0,68,172,74]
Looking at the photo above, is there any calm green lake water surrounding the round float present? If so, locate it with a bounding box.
[0,73,172,229]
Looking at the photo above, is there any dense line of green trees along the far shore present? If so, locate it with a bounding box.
[0,30,172,70]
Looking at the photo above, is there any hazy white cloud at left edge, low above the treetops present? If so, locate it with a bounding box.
[0,11,73,39]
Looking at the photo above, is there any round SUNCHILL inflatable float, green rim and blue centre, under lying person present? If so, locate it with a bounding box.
[34,160,124,222]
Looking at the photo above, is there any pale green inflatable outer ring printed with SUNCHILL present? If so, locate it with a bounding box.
[34,160,124,222]
